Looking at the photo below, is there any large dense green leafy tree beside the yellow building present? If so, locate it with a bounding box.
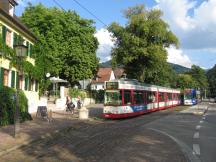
[21,4,99,83]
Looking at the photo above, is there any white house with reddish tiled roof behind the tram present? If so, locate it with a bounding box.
[91,68,115,90]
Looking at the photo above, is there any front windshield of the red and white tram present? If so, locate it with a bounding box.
[104,91,122,105]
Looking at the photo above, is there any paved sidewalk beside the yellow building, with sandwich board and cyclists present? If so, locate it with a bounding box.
[0,104,104,156]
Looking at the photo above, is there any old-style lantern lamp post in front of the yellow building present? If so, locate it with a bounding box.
[14,45,28,138]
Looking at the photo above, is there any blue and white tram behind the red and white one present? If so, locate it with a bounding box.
[182,89,200,105]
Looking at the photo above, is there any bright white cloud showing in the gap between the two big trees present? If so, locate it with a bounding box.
[95,28,115,62]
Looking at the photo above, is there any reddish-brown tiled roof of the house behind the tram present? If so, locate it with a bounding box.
[92,68,112,83]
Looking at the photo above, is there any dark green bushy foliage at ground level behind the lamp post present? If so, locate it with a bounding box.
[0,87,32,125]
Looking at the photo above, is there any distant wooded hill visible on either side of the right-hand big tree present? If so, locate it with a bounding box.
[99,61,190,74]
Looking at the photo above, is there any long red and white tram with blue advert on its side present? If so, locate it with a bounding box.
[103,79,180,118]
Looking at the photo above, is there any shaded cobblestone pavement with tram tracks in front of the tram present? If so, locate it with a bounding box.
[1,107,187,162]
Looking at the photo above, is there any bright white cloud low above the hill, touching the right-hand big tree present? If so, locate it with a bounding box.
[166,46,193,68]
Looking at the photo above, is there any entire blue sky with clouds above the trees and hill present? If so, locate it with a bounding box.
[16,0,216,69]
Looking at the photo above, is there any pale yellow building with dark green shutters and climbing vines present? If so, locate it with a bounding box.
[0,0,39,113]
